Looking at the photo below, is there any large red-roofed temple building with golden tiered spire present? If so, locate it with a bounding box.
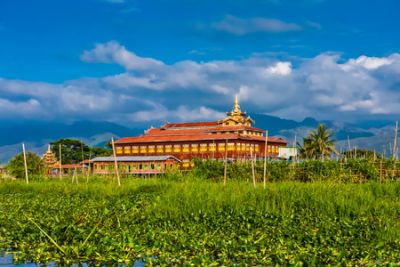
[115,97,287,168]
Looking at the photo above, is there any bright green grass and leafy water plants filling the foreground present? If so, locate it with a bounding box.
[0,177,400,265]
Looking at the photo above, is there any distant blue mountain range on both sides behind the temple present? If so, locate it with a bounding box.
[0,114,394,164]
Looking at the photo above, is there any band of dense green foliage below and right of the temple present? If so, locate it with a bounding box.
[193,158,400,183]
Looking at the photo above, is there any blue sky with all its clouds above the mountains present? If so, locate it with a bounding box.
[0,0,400,124]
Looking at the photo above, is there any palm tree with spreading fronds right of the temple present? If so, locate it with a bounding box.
[299,124,338,159]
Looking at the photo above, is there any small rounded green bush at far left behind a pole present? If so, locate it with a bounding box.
[6,152,44,178]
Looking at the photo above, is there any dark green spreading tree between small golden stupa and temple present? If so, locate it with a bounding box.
[50,139,112,164]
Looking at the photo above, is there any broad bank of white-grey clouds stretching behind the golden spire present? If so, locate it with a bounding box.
[0,41,400,125]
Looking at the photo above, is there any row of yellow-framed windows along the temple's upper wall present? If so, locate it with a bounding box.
[116,143,279,155]
